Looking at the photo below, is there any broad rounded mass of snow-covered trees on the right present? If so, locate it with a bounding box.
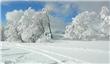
[64,7,110,40]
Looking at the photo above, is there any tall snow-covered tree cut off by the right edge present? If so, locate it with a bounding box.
[99,6,110,39]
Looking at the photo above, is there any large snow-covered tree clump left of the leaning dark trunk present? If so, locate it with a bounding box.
[5,7,51,42]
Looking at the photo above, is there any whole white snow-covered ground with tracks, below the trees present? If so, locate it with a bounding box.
[0,40,110,64]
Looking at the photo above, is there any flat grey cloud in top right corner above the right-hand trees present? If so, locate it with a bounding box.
[75,0,110,12]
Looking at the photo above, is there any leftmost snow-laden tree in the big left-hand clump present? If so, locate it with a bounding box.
[5,10,23,42]
